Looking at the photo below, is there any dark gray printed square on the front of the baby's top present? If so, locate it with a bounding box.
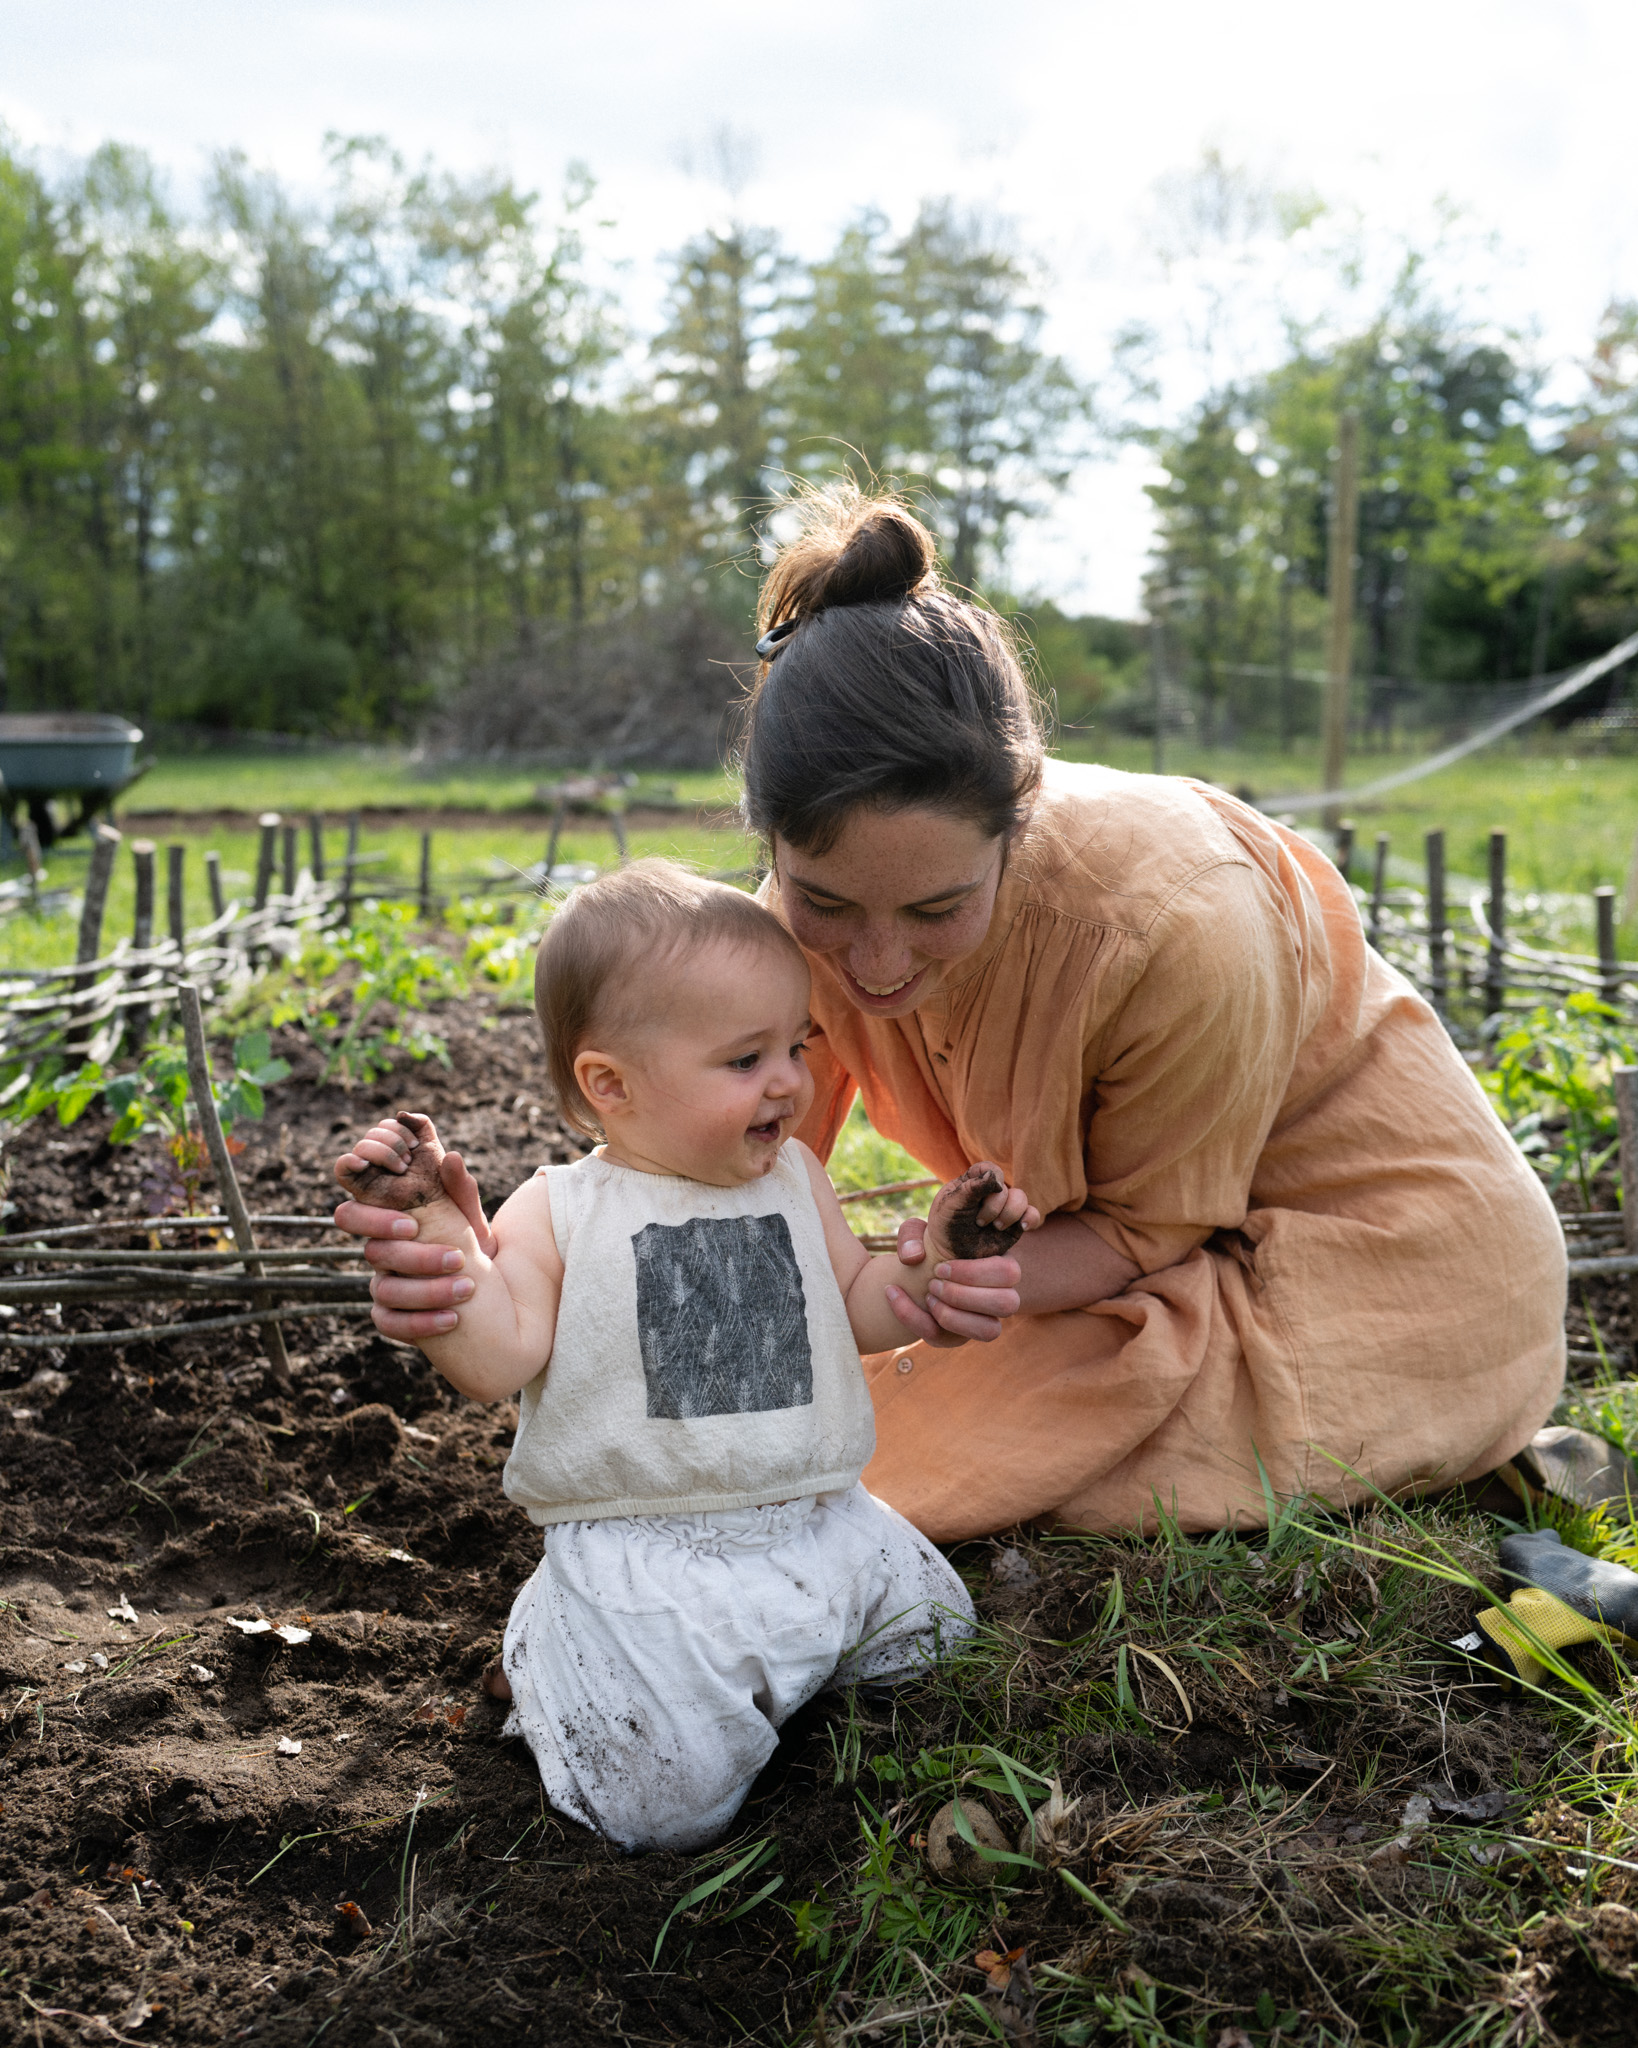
[631,1214,813,1421]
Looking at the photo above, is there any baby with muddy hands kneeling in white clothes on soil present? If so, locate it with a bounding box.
[336,860,1040,1849]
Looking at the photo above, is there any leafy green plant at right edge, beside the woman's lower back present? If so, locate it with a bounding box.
[1480,991,1638,1208]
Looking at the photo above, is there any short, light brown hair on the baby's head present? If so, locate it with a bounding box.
[534,860,803,1139]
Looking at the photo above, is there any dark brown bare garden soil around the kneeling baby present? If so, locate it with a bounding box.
[0,1012,1638,2048]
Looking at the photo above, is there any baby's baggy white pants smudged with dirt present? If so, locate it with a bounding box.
[502,1487,973,1849]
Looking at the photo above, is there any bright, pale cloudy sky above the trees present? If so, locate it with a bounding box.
[0,0,1638,616]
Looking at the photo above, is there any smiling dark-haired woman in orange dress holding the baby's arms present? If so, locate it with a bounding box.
[352,496,1564,1542]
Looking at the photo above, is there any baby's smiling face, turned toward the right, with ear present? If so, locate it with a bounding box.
[604,944,813,1188]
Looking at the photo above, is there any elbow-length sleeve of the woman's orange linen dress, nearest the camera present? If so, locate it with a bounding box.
[1083,843,1317,1272]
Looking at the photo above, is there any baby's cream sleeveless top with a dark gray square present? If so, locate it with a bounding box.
[502,1145,876,1526]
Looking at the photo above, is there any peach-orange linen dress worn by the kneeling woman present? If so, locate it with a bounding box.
[770,762,1566,1542]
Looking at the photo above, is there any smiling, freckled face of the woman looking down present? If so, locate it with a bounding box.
[774,807,1007,1018]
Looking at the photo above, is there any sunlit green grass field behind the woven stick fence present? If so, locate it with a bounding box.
[0,735,1638,967]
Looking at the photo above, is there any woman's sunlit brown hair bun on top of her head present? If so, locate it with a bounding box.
[758,483,940,629]
